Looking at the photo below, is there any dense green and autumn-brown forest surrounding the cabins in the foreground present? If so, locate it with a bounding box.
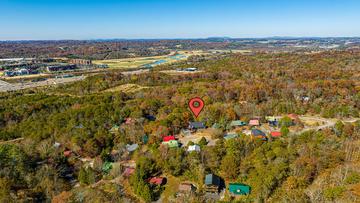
[0,51,360,202]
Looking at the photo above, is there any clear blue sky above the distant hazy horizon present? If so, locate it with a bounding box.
[0,0,360,40]
